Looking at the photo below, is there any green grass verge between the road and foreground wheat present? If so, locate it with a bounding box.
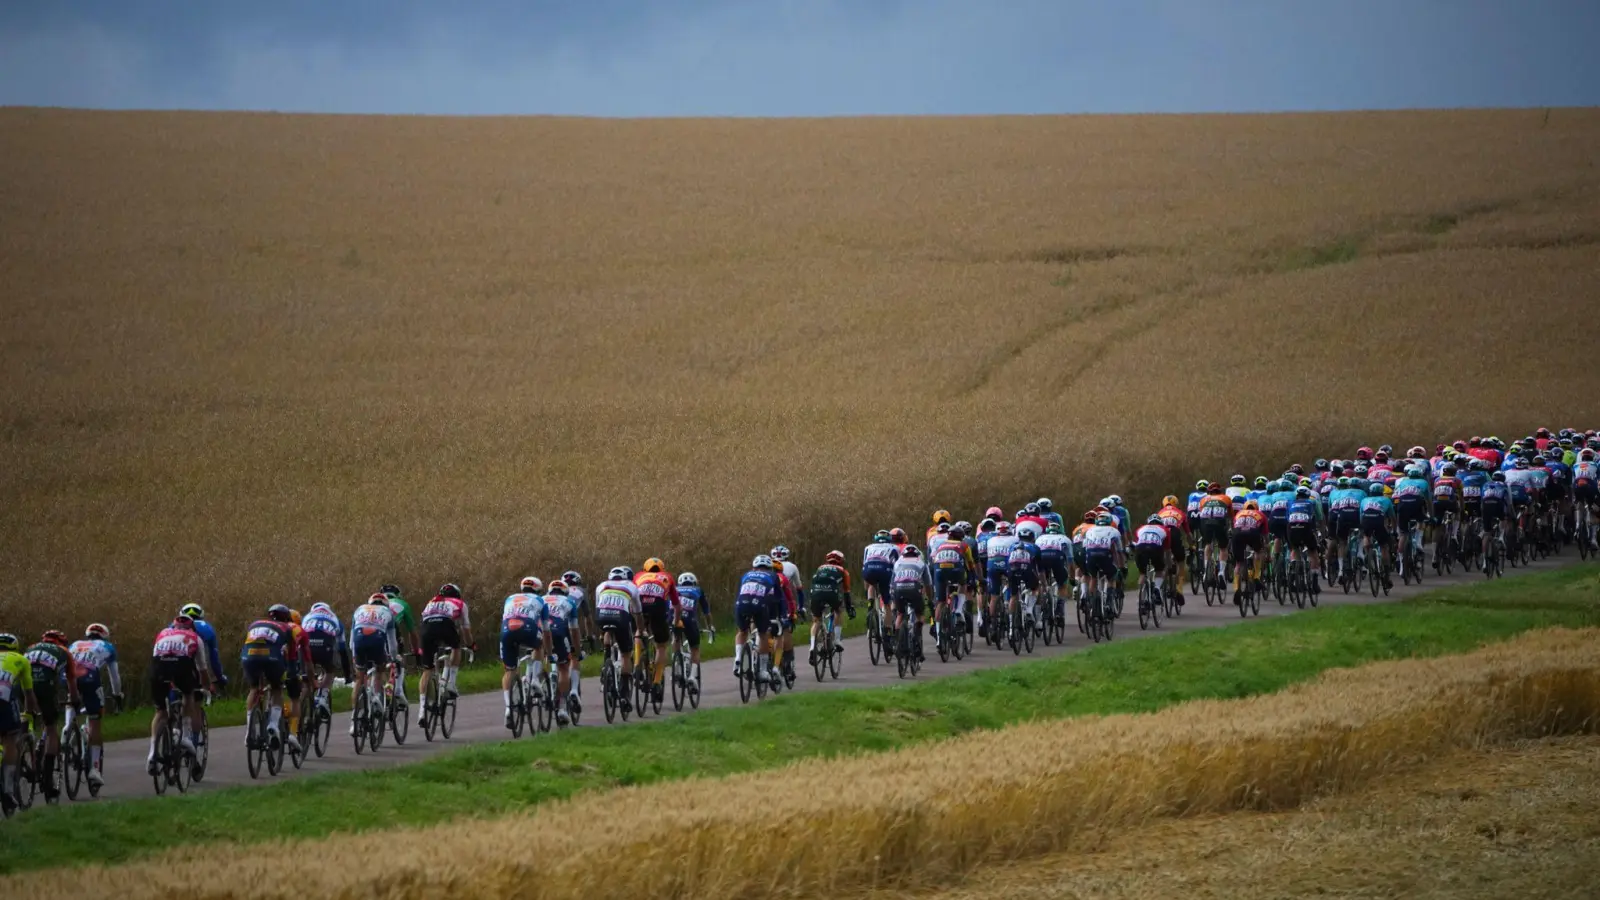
[0,565,1600,871]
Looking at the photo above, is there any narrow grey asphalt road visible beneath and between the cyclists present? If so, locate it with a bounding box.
[81,554,1578,802]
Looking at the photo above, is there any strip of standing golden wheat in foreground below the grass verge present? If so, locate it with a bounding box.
[12,629,1600,900]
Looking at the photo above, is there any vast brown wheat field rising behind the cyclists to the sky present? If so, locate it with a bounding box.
[0,109,1600,637]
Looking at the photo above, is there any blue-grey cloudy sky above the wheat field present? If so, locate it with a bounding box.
[0,0,1600,115]
